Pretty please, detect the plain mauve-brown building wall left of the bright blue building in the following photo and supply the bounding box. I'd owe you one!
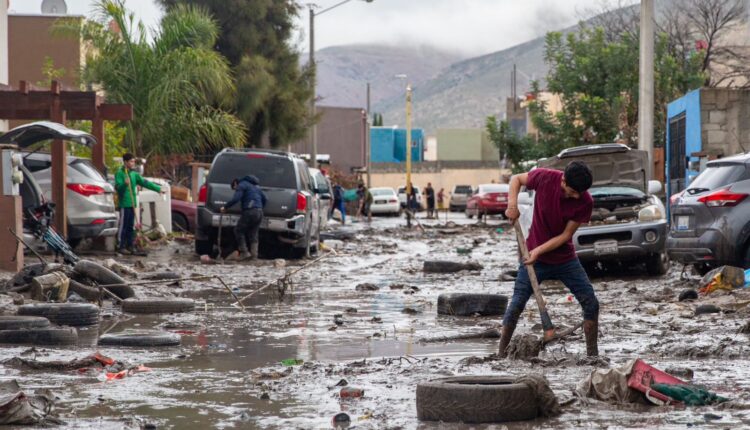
[290,106,367,173]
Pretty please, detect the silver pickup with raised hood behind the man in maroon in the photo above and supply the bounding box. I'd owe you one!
[519,144,669,275]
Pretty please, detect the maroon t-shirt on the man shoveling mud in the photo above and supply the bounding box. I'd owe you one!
[526,169,594,264]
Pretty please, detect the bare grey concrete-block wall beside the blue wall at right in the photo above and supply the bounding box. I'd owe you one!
[701,88,750,156]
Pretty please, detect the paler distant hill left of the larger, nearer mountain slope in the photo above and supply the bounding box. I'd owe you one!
[310,45,464,108]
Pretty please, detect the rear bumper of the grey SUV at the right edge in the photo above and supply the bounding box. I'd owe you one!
[667,230,737,265]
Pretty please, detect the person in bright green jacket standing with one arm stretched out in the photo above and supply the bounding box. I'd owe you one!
[115,153,162,255]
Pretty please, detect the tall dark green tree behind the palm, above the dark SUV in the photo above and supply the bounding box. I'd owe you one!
[159,0,317,146]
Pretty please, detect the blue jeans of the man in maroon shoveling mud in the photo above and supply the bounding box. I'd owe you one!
[503,258,599,326]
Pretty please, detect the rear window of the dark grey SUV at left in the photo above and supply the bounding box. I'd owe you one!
[208,153,297,189]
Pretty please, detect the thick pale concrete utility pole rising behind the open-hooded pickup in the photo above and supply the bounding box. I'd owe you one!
[638,0,654,177]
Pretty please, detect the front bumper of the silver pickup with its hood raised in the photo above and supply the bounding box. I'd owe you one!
[573,221,667,262]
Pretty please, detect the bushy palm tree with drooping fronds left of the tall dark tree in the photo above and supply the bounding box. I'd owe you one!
[57,0,245,155]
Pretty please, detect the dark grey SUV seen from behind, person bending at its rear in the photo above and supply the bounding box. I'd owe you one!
[195,149,320,257]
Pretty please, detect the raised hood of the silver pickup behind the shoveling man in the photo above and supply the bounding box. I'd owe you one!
[538,143,651,194]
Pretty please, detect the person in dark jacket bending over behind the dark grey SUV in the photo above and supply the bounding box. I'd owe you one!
[221,175,266,260]
